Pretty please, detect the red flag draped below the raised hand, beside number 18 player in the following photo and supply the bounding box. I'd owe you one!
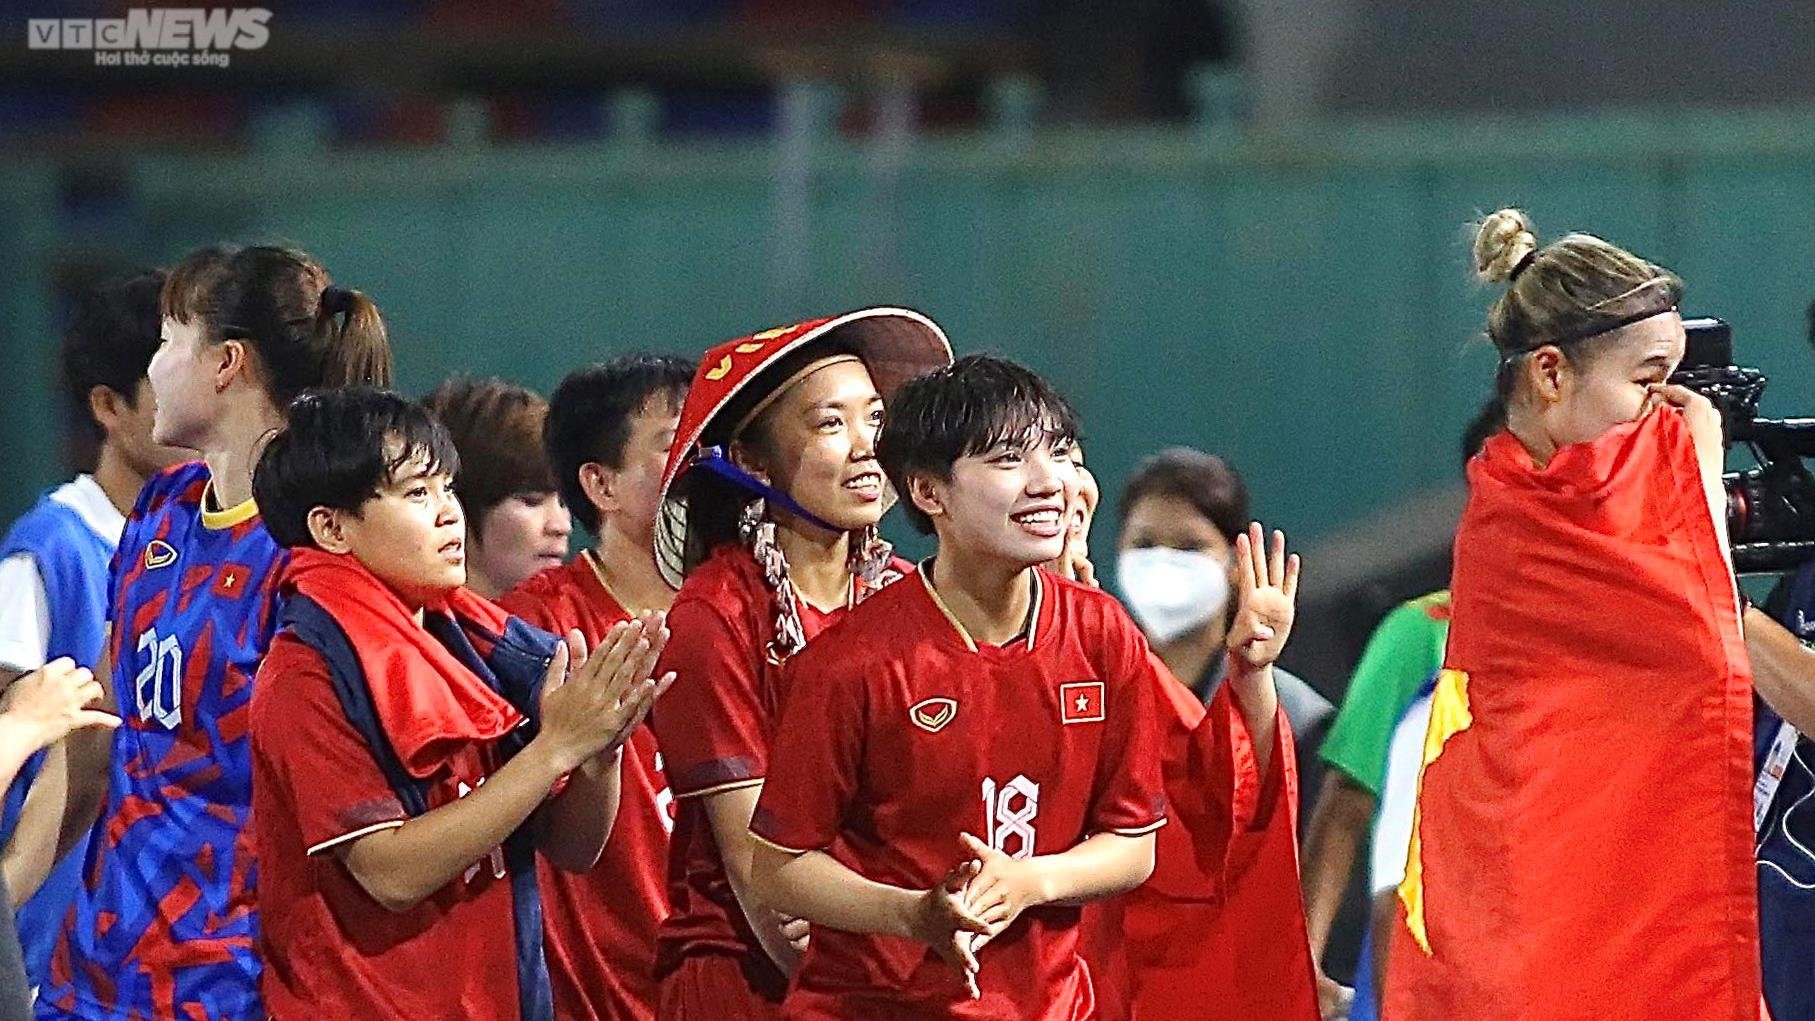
[1084,667,1318,1021]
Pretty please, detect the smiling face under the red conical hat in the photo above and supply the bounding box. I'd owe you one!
[735,359,886,531]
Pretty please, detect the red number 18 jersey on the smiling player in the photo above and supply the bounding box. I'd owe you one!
[751,569,1169,1021]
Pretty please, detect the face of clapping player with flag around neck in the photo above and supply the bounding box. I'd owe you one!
[323,453,466,606]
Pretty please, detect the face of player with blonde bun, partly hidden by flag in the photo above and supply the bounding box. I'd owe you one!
[1525,312,1686,448]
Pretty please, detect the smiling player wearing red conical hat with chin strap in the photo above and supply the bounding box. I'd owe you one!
[653,308,951,1021]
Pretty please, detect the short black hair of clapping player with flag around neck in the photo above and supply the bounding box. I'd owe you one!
[252,386,459,548]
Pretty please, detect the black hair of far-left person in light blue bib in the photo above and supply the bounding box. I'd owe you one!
[60,270,169,466]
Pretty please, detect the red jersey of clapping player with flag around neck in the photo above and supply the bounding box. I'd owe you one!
[250,631,519,1021]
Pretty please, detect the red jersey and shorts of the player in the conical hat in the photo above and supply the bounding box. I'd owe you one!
[650,546,913,999]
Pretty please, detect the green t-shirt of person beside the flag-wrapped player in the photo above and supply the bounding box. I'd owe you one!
[1321,589,1450,796]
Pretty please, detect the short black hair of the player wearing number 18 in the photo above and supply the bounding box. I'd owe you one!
[877,354,1078,535]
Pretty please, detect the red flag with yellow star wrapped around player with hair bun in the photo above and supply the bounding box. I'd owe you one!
[1385,410,1759,1021]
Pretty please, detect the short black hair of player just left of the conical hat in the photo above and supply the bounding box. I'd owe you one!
[543,354,695,535]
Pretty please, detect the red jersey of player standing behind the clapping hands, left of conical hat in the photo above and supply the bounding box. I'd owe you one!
[499,549,673,1021]
